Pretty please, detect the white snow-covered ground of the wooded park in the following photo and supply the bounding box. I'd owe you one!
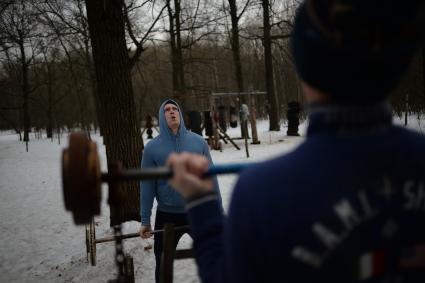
[0,114,425,282]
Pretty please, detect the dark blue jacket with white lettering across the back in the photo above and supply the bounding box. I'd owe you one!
[187,105,425,283]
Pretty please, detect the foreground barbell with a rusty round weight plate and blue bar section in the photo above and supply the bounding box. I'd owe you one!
[62,133,251,225]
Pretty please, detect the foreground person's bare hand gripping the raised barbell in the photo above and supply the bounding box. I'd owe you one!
[167,153,213,199]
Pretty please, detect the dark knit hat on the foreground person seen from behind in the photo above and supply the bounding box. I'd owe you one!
[292,0,425,104]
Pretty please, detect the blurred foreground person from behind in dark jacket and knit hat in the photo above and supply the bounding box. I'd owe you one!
[168,0,425,283]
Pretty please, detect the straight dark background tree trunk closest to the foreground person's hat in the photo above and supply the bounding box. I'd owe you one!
[262,0,280,131]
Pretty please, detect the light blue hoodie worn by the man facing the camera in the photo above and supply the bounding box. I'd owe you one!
[140,100,221,225]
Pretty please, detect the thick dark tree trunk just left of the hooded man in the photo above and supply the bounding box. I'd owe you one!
[86,0,142,226]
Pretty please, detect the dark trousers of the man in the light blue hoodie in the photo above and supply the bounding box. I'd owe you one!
[153,210,188,283]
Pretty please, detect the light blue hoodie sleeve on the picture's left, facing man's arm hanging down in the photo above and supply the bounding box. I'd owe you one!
[140,148,156,225]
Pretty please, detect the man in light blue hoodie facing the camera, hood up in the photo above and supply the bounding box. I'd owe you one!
[140,99,221,282]
